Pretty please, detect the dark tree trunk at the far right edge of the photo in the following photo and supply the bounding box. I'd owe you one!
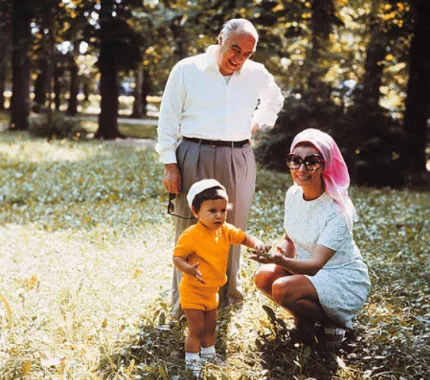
[404,0,430,172]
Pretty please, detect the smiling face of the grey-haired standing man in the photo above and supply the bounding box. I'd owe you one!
[218,32,255,75]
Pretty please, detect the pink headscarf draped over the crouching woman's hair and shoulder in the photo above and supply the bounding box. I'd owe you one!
[290,128,358,231]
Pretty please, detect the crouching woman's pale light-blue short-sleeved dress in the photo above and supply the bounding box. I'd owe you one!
[284,185,370,328]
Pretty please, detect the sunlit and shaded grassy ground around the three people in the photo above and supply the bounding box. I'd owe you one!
[0,132,430,379]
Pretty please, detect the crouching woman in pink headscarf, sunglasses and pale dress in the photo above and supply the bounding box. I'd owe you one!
[252,129,370,345]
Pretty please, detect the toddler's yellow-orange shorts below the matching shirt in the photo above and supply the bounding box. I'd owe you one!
[179,281,219,311]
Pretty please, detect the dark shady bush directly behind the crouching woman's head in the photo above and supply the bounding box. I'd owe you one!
[256,93,422,187]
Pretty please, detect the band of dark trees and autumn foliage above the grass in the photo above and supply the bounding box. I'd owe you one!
[0,0,430,186]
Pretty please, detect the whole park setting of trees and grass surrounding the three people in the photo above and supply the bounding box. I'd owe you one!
[0,0,430,379]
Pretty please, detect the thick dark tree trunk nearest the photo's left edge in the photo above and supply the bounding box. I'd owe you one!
[10,0,31,130]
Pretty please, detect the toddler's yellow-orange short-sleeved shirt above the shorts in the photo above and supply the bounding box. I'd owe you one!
[173,222,246,287]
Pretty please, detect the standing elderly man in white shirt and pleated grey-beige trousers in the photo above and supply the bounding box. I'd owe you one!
[156,19,284,312]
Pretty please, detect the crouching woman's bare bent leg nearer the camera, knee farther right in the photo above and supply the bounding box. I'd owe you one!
[272,274,331,323]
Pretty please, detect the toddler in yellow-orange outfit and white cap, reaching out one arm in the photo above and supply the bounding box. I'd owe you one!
[173,179,270,376]
